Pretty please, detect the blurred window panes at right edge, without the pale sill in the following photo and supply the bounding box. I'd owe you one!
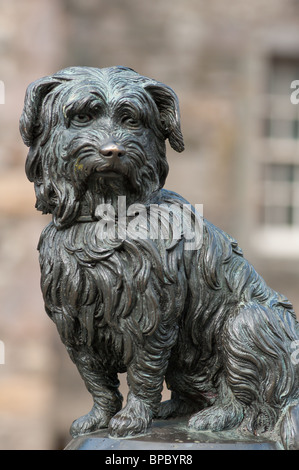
[261,57,299,227]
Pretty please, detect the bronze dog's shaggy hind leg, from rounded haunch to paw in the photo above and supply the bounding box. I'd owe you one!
[189,302,298,433]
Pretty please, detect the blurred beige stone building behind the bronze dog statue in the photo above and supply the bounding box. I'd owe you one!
[0,0,299,449]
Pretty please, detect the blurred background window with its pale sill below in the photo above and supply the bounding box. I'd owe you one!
[252,56,299,260]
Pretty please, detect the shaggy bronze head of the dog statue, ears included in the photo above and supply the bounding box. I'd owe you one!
[20,66,184,229]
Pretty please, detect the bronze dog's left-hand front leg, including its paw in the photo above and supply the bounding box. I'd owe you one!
[67,347,122,437]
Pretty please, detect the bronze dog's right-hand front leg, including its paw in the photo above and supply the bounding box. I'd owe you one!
[109,326,174,437]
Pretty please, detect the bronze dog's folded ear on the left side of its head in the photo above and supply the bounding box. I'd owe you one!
[19,77,61,147]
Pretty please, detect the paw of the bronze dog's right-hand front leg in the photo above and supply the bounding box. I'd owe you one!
[109,396,152,437]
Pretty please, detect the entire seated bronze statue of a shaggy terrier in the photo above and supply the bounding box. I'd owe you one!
[20,67,299,448]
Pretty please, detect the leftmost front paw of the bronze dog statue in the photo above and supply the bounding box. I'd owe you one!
[70,407,111,437]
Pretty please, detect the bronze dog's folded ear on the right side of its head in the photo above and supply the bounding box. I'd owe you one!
[144,82,184,152]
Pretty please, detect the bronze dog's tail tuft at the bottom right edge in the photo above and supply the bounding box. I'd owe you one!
[277,402,299,450]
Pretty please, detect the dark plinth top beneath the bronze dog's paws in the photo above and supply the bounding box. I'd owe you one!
[65,418,282,453]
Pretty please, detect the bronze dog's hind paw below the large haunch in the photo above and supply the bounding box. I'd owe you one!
[188,404,244,431]
